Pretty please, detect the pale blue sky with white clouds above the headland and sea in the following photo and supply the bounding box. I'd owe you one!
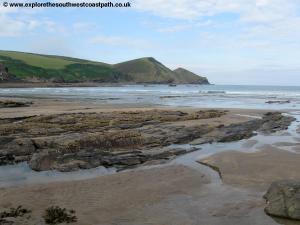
[0,0,300,86]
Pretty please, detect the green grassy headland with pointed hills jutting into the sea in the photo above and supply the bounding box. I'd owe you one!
[0,51,209,84]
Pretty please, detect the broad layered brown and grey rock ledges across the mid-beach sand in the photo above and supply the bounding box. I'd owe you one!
[0,110,294,171]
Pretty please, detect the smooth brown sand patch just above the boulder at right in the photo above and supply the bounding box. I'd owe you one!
[200,145,300,191]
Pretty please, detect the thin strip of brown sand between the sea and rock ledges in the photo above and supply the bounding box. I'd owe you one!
[0,96,278,118]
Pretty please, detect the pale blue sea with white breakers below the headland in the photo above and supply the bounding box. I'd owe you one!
[0,85,300,110]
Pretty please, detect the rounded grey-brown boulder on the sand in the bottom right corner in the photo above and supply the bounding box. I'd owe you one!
[264,180,300,220]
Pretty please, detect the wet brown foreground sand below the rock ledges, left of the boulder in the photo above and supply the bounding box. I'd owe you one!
[0,166,277,225]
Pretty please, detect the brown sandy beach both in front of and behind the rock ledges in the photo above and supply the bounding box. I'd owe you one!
[0,95,300,225]
